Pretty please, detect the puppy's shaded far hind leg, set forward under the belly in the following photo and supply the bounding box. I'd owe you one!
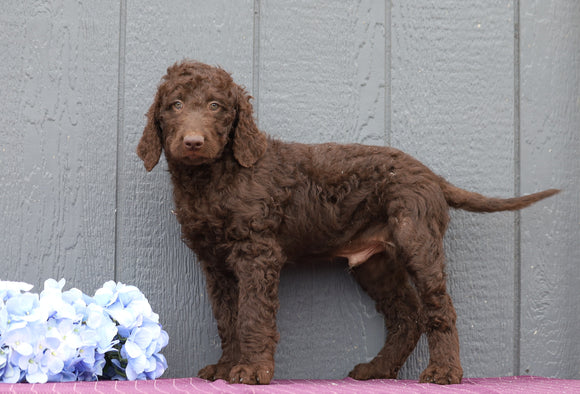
[348,253,422,380]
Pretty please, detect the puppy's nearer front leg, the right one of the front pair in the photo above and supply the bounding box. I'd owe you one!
[229,240,284,384]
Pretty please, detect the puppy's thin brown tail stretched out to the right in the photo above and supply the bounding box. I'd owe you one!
[439,178,560,212]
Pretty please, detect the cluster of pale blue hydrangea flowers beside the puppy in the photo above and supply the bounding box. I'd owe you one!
[0,279,168,383]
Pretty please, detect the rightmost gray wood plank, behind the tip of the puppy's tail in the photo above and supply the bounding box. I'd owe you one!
[520,0,580,379]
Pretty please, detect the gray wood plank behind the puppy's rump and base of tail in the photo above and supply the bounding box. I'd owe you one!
[391,0,514,378]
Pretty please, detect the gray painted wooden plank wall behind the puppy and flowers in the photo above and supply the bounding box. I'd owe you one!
[0,0,580,379]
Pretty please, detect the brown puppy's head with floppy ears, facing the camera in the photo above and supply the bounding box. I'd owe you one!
[137,61,267,171]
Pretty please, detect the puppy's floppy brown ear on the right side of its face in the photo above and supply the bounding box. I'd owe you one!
[233,86,268,167]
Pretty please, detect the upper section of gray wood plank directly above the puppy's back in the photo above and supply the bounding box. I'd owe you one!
[259,0,385,145]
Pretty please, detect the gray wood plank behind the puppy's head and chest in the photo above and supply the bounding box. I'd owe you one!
[117,0,254,377]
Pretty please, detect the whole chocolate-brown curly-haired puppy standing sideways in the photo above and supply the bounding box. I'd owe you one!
[137,61,557,384]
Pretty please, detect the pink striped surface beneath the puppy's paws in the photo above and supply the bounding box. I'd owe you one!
[0,376,580,394]
